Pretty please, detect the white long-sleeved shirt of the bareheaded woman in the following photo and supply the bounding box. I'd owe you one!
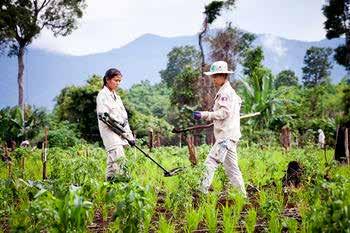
[96,86,133,151]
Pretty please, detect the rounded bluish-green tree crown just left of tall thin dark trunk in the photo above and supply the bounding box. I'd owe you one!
[160,45,200,87]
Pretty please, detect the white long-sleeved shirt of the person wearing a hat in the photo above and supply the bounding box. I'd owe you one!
[201,81,242,142]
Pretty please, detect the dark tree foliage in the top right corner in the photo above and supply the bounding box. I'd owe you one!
[322,0,350,71]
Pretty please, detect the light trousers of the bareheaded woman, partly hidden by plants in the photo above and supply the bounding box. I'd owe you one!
[106,145,125,178]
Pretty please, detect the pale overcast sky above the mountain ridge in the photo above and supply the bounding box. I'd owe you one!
[32,0,325,55]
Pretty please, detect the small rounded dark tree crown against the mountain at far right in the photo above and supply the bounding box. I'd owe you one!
[302,47,332,87]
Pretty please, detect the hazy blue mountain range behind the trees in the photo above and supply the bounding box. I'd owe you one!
[0,34,345,108]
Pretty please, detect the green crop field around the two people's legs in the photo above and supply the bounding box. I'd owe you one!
[0,144,350,232]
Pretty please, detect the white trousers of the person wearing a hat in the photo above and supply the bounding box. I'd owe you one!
[201,140,247,196]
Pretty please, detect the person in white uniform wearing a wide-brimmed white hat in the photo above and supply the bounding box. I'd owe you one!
[193,61,246,196]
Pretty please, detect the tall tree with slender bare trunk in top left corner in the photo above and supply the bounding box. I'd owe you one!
[0,0,85,118]
